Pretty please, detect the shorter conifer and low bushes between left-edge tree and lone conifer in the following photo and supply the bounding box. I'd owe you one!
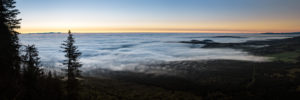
[16,45,65,100]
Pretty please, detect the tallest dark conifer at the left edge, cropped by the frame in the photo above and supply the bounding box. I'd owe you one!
[0,0,21,100]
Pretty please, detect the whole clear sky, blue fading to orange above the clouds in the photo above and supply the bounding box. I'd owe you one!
[16,0,300,33]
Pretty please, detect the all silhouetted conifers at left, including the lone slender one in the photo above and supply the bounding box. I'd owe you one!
[0,0,81,100]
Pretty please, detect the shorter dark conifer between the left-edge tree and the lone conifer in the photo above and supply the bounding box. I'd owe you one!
[22,45,43,100]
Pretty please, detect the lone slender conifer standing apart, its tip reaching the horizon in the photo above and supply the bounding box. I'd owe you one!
[62,30,82,100]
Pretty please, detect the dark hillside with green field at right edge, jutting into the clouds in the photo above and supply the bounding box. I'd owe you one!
[204,36,300,63]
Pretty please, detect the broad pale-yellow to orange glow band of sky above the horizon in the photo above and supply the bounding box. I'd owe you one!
[18,21,300,33]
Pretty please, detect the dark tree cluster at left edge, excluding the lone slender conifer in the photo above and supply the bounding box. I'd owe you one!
[0,0,64,100]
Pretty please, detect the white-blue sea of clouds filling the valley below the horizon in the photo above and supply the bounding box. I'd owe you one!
[20,33,288,71]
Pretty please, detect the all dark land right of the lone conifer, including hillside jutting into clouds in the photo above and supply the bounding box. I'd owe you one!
[82,37,300,100]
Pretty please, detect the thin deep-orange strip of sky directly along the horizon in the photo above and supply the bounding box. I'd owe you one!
[17,28,300,34]
